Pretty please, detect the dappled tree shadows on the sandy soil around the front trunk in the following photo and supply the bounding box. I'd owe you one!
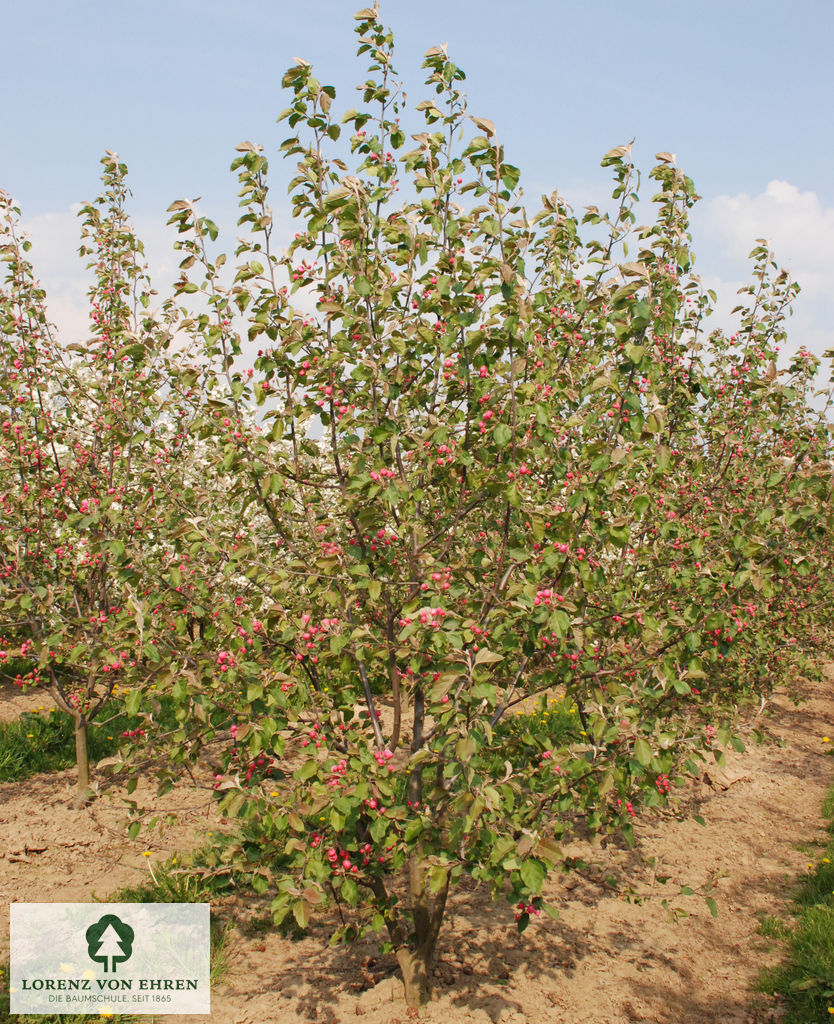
[211,675,834,1024]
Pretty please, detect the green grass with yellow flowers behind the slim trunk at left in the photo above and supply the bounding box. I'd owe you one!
[0,698,138,782]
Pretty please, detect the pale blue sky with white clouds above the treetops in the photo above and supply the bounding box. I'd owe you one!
[0,0,834,362]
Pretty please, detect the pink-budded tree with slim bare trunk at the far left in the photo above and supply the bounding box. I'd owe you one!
[0,154,182,803]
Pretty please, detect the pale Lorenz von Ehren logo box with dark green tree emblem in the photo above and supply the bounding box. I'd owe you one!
[9,903,211,1014]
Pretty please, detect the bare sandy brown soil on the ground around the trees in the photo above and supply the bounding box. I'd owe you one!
[0,672,834,1024]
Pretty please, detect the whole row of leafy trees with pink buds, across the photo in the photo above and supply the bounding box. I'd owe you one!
[0,9,834,1005]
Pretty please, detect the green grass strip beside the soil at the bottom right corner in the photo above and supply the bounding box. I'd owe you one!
[756,786,834,1024]
